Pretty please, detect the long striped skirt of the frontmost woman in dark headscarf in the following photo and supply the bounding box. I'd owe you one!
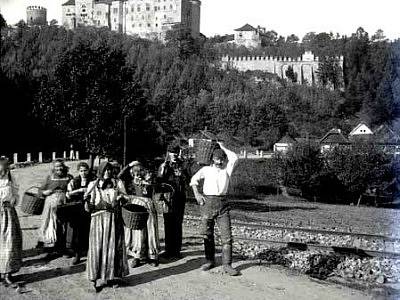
[87,211,129,282]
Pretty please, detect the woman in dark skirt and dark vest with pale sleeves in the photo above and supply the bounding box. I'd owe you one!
[66,162,94,265]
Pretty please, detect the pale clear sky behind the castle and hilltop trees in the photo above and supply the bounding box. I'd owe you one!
[0,0,400,39]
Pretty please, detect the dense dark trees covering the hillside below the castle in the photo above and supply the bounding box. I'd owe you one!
[0,22,400,164]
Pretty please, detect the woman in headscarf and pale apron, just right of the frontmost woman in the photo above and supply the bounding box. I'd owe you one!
[119,161,160,268]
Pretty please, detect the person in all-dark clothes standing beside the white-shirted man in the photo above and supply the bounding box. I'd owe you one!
[158,146,190,258]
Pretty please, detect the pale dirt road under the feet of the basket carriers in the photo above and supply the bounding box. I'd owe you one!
[0,165,373,300]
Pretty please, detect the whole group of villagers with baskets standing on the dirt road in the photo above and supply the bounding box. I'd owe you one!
[0,143,238,292]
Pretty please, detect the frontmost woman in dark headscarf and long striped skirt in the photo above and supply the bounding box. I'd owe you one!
[85,162,129,292]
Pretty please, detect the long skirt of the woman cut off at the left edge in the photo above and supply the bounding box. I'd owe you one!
[0,207,22,274]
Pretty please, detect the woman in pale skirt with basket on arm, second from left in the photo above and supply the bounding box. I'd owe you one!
[37,159,73,254]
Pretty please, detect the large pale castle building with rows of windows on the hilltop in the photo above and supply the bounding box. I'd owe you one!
[62,0,201,40]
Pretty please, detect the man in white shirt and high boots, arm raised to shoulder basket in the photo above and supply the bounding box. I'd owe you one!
[190,143,239,276]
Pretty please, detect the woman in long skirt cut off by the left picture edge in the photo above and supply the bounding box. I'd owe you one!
[0,157,22,284]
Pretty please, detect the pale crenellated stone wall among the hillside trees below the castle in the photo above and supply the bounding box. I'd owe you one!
[222,51,343,85]
